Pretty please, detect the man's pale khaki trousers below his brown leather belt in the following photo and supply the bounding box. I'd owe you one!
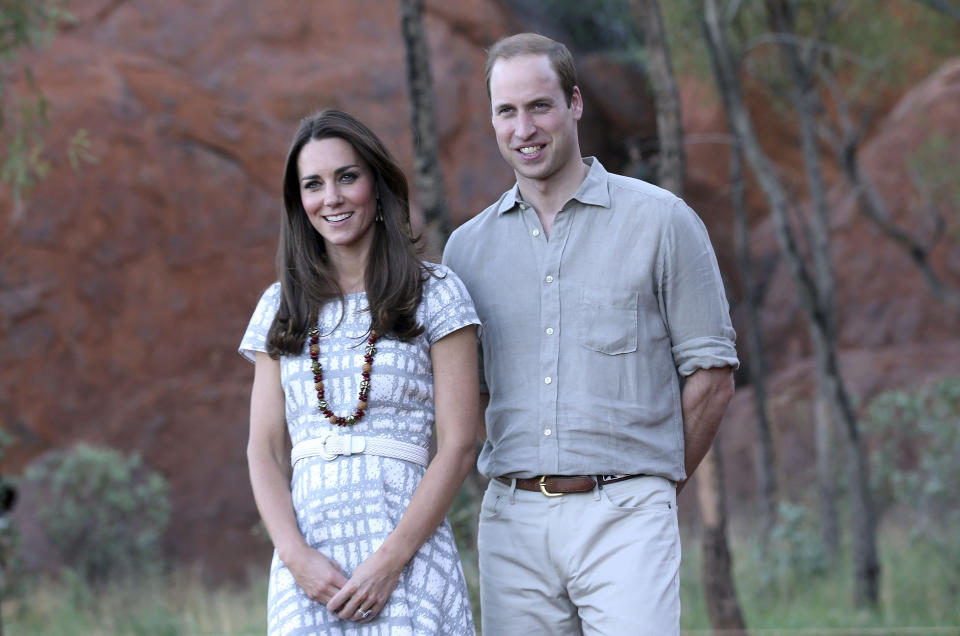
[478,477,680,636]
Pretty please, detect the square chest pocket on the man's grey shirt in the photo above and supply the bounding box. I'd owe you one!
[580,287,637,355]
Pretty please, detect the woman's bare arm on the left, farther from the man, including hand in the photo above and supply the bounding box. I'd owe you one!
[247,352,347,603]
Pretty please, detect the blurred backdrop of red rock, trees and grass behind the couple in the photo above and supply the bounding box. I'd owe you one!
[0,0,960,634]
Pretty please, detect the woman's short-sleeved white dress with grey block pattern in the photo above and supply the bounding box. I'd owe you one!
[240,265,480,636]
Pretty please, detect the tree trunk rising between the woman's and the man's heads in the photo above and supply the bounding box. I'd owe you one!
[400,0,450,261]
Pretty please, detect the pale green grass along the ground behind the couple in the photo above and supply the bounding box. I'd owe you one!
[3,528,960,636]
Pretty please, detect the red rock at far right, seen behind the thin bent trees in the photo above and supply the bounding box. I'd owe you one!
[700,58,960,503]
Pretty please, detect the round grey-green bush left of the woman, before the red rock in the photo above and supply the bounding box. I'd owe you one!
[25,444,170,583]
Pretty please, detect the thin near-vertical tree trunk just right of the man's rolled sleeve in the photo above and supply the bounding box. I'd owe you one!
[730,143,777,550]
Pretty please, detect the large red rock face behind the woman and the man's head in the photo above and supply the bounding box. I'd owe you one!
[0,0,654,574]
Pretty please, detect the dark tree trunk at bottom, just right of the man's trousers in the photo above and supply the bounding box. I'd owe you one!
[697,441,747,634]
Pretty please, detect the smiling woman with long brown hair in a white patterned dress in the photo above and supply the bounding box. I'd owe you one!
[240,110,479,634]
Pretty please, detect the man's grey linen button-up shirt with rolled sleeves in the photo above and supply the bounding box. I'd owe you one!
[443,157,738,481]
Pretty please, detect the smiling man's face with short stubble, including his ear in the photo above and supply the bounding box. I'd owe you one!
[490,55,583,181]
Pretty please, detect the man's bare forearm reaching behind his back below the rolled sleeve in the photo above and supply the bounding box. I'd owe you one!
[677,367,733,492]
